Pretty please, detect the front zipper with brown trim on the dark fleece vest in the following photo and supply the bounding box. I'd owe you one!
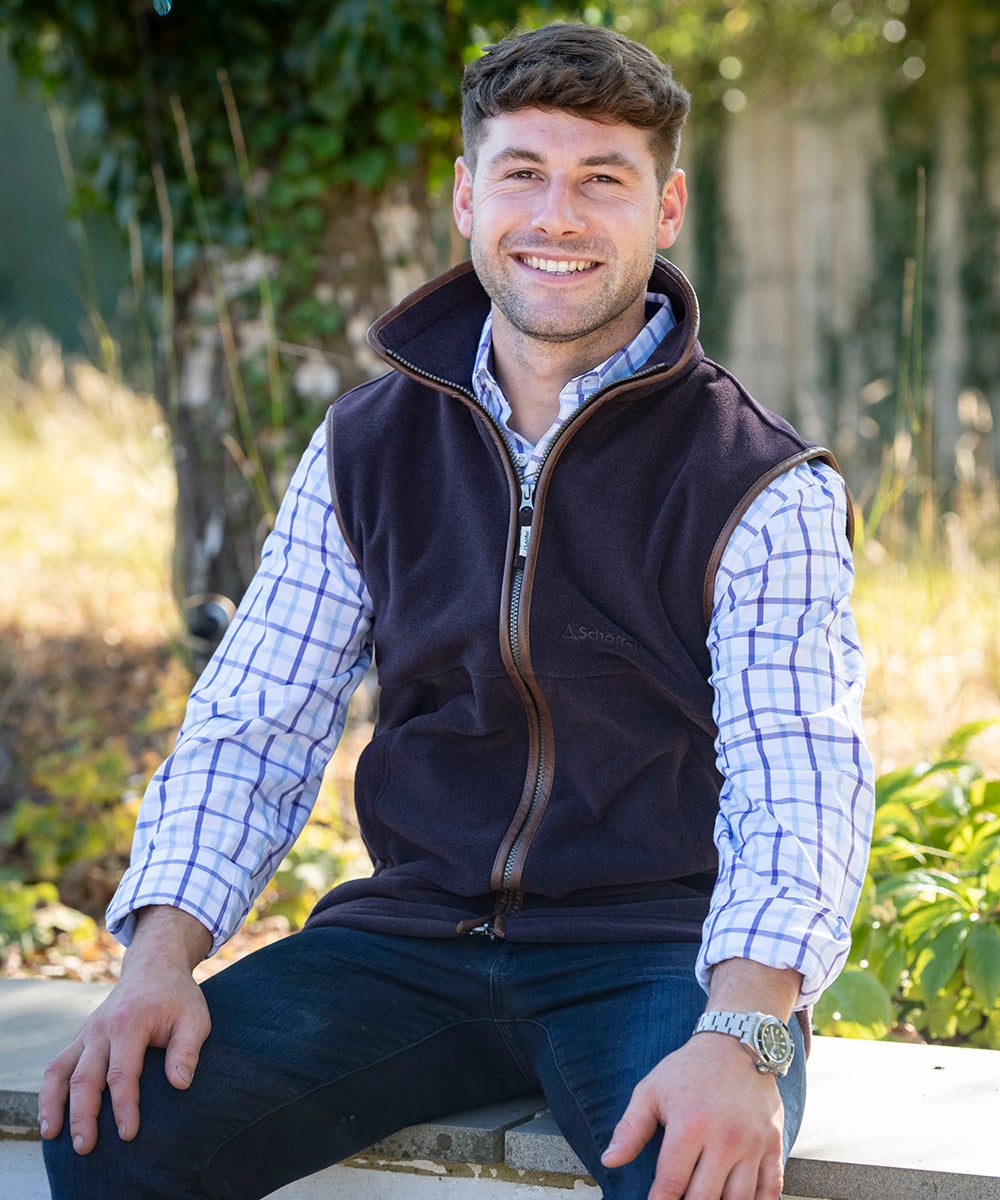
[382,346,661,940]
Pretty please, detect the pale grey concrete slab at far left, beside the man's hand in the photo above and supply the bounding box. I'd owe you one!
[0,979,112,1128]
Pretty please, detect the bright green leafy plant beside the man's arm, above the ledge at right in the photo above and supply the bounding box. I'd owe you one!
[815,721,1000,1049]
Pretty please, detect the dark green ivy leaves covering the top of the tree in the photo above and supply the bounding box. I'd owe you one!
[5,0,550,309]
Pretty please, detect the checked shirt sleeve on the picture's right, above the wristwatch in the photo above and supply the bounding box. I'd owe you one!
[697,463,874,1007]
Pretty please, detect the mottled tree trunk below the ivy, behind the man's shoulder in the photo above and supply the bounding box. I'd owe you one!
[161,180,447,658]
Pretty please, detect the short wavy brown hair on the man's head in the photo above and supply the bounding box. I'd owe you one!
[462,24,691,186]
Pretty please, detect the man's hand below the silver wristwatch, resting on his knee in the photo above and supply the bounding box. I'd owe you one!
[601,1033,784,1200]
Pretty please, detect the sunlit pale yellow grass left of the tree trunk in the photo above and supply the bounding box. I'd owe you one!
[0,335,179,647]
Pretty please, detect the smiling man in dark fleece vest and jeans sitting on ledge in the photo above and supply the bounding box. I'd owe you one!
[40,26,872,1200]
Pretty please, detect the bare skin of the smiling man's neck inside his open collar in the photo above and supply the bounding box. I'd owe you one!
[493,294,646,445]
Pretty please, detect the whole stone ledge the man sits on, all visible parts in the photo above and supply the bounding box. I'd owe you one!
[0,979,1000,1200]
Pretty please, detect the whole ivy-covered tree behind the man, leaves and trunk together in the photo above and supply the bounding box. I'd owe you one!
[0,0,573,601]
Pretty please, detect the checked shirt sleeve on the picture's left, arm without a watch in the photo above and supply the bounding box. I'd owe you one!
[107,428,372,952]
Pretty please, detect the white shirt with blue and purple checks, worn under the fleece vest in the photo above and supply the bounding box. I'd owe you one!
[107,296,874,1004]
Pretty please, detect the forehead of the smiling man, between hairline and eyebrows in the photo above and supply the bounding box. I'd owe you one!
[477,108,655,173]
